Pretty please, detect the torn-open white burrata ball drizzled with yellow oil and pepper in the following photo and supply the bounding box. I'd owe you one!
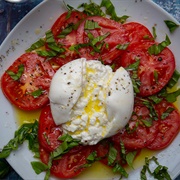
[49,58,134,145]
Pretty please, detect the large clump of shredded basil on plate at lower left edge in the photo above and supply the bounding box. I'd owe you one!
[0,121,39,159]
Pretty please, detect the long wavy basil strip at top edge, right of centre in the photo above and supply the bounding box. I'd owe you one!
[100,0,129,23]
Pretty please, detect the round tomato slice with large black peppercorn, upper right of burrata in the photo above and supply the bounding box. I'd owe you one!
[121,42,175,96]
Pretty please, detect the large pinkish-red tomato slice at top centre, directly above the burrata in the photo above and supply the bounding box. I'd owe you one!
[77,16,128,63]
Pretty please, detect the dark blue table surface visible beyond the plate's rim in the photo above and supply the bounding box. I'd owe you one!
[0,0,180,180]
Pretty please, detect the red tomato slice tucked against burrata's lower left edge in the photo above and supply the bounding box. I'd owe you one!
[38,105,62,152]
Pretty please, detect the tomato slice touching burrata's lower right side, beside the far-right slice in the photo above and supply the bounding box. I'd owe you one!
[112,98,158,149]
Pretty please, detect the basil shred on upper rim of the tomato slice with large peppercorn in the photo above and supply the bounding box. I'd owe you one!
[148,35,171,55]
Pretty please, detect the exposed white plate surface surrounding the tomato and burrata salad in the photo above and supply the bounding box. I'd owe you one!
[0,0,180,179]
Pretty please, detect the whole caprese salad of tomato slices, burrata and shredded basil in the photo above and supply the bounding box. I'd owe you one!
[0,0,180,179]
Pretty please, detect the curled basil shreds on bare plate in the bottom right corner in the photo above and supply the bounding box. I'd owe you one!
[141,156,171,180]
